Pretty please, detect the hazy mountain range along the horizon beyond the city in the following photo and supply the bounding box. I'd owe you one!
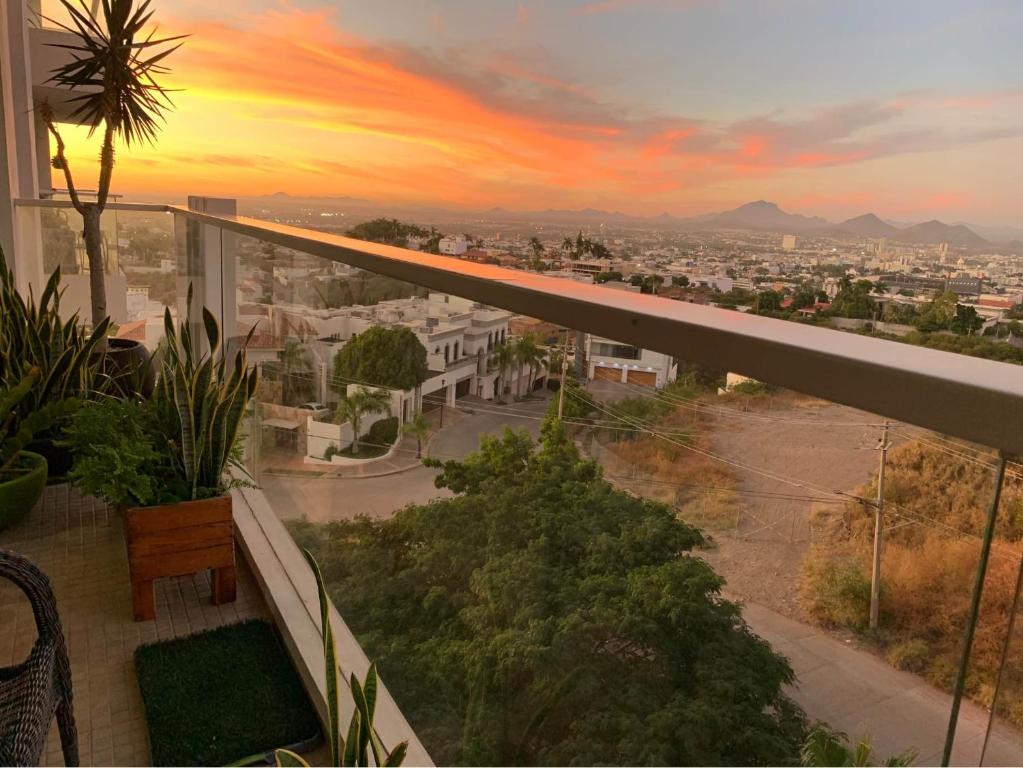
[250,192,1023,247]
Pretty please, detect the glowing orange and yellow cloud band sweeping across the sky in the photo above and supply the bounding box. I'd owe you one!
[53,0,1020,218]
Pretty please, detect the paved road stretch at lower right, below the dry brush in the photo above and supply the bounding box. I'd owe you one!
[743,603,1023,765]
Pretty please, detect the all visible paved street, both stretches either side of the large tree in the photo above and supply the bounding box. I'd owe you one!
[263,402,1023,765]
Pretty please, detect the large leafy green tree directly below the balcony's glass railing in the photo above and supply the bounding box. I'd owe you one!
[294,420,805,765]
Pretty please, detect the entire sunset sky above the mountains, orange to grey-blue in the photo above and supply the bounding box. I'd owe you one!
[53,0,1023,225]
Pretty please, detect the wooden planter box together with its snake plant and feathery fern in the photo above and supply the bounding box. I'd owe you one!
[68,290,258,621]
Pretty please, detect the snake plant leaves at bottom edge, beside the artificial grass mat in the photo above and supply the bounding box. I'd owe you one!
[274,550,408,768]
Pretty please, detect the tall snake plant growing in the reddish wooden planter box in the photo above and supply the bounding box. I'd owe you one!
[155,287,259,499]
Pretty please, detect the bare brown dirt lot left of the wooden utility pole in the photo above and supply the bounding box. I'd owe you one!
[601,393,908,620]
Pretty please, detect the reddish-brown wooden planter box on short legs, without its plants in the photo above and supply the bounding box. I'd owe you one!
[125,496,235,622]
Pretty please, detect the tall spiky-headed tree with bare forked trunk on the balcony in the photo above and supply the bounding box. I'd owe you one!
[37,0,185,324]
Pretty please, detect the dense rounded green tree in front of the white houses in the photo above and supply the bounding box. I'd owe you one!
[333,325,429,395]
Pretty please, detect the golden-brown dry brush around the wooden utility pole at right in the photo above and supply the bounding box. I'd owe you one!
[801,443,1023,725]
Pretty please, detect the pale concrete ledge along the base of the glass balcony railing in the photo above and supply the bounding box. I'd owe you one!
[231,488,434,766]
